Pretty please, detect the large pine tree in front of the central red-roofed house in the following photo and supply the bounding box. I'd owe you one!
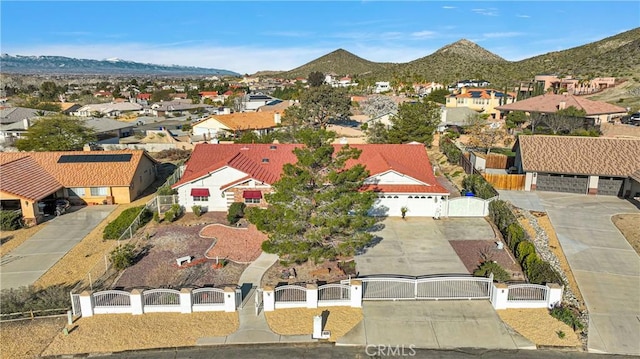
[246,129,377,262]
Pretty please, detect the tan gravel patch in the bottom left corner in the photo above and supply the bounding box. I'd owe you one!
[0,316,67,359]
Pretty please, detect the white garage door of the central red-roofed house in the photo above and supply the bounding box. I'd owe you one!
[371,194,438,217]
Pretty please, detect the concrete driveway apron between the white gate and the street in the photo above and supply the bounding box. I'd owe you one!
[337,300,535,349]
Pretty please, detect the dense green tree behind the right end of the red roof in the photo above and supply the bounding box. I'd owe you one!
[388,100,440,146]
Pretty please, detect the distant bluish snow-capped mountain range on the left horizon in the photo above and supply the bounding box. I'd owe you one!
[0,54,240,76]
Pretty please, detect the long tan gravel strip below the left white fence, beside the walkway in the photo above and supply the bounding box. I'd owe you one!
[42,312,239,355]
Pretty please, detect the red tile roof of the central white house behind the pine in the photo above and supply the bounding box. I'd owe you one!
[173,144,448,193]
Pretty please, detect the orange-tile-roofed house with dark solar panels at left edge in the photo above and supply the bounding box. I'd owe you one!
[0,150,157,224]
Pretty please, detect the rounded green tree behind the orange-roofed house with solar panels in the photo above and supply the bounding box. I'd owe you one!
[16,115,97,151]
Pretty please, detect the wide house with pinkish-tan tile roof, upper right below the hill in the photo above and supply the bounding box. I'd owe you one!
[496,93,627,126]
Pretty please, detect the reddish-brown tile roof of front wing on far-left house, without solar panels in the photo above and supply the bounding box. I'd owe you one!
[0,157,62,201]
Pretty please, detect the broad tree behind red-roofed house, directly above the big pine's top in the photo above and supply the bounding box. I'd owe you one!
[298,85,351,129]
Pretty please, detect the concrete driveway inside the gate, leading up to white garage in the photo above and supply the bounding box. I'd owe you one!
[355,217,495,276]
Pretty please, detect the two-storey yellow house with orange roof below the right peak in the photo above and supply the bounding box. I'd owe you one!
[445,87,516,119]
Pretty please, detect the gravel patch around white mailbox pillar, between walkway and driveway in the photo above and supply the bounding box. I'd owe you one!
[265,307,363,342]
